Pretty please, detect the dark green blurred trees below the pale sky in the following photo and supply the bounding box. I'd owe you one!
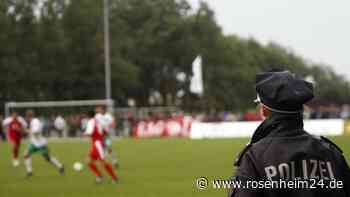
[0,0,350,111]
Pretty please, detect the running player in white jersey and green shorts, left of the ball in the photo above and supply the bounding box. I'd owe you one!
[24,110,64,177]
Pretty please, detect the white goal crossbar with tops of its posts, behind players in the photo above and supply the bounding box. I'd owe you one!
[5,99,114,117]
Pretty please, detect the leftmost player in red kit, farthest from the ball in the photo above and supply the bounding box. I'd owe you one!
[3,111,27,167]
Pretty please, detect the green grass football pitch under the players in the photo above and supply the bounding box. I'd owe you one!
[0,137,350,197]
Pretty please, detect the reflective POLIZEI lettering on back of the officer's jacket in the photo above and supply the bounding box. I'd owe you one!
[265,159,334,180]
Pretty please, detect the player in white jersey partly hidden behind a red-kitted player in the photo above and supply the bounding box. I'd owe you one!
[95,106,119,167]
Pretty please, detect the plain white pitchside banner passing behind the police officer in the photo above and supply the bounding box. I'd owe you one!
[190,119,344,139]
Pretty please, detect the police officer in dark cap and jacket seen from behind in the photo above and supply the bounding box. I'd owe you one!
[229,71,350,197]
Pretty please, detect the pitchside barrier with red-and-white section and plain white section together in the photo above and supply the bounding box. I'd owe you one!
[133,116,345,139]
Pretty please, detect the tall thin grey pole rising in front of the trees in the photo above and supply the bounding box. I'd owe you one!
[103,0,112,100]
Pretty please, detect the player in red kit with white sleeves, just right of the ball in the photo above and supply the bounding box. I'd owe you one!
[84,111,118,183]
